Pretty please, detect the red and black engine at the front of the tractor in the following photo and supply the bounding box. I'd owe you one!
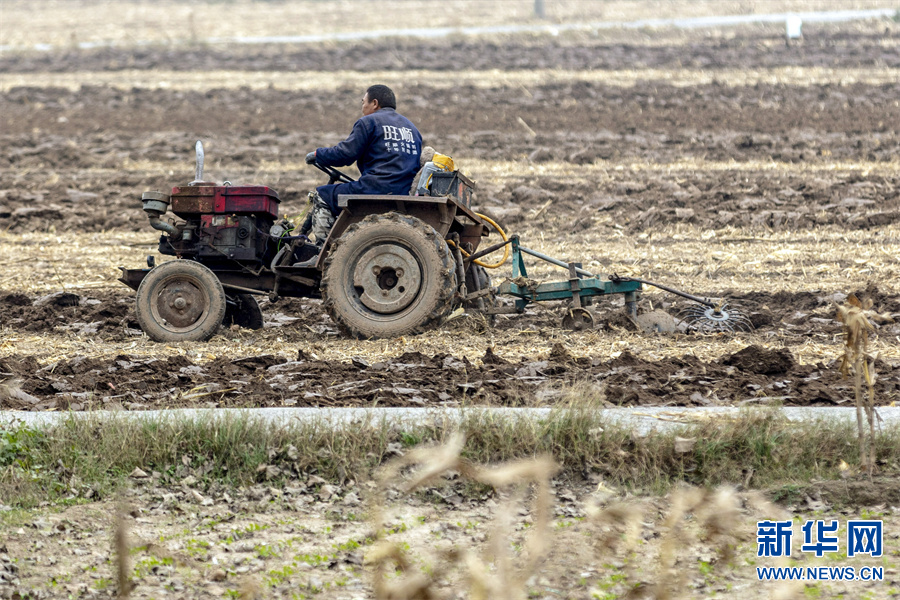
[142,182,279,264]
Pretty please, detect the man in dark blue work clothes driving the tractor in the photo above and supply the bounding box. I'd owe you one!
[295,85,422,266]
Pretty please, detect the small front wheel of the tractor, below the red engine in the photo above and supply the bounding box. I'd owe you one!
[135,260,225,342]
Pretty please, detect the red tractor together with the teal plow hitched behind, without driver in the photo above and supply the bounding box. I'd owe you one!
[119,141,752,342]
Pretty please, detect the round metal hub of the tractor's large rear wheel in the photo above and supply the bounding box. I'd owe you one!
[353,245,422,314]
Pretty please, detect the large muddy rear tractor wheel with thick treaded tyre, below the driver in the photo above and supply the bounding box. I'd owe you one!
[321,213,457,338]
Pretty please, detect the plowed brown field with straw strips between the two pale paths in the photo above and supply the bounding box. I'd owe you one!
[0,20,900,410]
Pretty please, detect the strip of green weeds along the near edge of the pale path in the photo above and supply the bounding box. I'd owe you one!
[0,406,900,508]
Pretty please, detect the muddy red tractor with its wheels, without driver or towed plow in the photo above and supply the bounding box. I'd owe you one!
[119,141,490,342]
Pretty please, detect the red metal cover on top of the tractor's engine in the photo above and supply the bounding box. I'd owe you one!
[171,184,280,219]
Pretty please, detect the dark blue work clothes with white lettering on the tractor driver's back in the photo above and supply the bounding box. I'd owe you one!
[316,108,422,215]
